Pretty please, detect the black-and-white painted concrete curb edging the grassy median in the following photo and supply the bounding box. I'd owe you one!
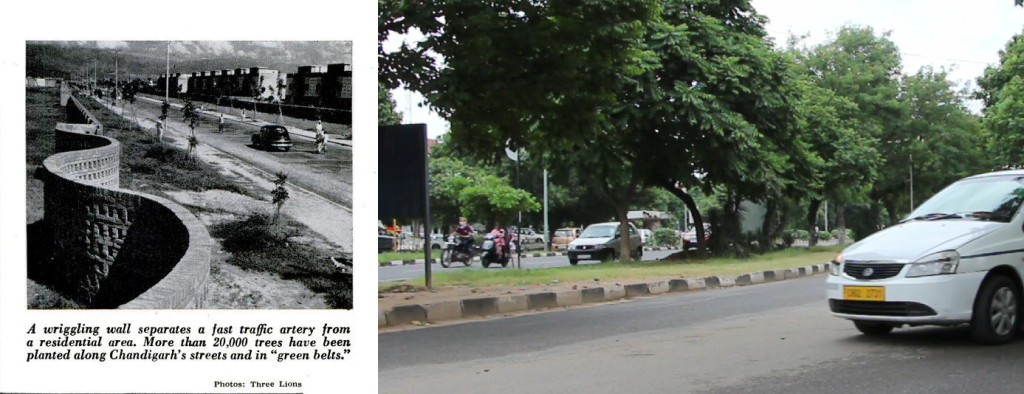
[377,263,828,327]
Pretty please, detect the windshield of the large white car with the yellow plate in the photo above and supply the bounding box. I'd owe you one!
[904,175,1024,222]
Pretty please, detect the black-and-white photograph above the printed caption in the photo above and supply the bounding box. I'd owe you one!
[25,40,353,309]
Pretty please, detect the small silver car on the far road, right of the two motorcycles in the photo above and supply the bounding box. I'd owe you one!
[568,222,643,265]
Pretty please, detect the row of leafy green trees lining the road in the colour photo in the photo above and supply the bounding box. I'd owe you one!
[378,0,1024,260]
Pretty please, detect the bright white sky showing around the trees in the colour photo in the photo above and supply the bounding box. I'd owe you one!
[392,0,1024,138]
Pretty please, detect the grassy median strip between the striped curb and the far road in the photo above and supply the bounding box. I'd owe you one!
[378,246,845,291]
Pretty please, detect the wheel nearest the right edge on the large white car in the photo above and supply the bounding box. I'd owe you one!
[971,275,1021,345]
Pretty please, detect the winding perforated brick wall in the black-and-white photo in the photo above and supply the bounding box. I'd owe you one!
[43,97,212,309]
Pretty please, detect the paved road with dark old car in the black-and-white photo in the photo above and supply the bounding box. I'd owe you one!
[135,94,352,209]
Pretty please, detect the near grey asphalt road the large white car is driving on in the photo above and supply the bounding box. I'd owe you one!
[378,275,1024,393]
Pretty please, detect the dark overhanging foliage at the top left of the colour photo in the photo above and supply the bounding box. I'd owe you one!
[377,0,659,157]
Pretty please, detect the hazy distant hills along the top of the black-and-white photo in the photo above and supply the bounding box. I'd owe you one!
[26,41,352,79]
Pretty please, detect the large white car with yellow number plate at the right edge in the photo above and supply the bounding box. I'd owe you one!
[826,170,1024,344]
